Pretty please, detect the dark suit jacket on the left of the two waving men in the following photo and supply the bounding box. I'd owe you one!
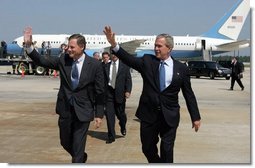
[29,50,104,121]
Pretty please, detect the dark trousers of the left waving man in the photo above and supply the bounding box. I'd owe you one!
[58,107,90,163]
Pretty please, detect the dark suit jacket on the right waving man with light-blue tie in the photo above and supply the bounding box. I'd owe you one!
[114,47,200,127]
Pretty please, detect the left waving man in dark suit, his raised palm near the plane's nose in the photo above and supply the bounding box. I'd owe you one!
[24,28,104,163]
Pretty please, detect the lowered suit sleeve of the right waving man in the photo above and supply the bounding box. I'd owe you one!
[182,67,201,122]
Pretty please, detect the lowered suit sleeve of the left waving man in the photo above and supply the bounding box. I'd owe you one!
[95,63,105,118]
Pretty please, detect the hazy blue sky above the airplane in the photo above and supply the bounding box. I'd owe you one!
[0,0,252,55]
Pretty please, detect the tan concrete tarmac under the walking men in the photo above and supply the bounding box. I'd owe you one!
[0,66,252,165]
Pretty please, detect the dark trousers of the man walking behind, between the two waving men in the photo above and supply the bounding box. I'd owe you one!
[105,86,127,139]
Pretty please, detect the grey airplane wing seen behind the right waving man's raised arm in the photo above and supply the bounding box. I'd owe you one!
[104,39,146,55]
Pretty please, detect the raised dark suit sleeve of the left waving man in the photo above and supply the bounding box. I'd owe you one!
[28,49,59,70]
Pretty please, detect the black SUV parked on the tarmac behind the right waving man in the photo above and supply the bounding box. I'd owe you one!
[188,61,231,80]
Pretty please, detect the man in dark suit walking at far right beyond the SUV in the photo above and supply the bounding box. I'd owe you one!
[230,57,244,91]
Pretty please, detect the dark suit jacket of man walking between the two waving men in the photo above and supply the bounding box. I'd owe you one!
[104,60,132,103]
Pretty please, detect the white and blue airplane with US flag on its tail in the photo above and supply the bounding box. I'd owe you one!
[4,0,250,59]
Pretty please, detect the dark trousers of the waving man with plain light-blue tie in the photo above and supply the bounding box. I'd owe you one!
[140,113,177,163]
